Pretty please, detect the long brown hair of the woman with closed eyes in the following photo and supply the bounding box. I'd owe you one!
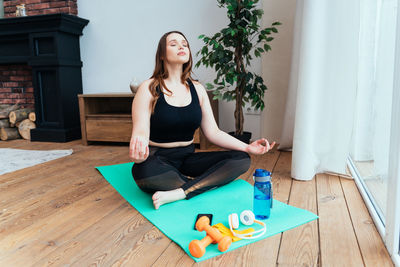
[149,31,193,113]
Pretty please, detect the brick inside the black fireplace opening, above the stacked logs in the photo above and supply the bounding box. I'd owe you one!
[0,65,34,108]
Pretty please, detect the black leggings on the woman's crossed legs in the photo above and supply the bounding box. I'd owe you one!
[132,144,250,199]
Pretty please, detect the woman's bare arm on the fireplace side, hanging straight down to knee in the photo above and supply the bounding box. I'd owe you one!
[129,80,153,163]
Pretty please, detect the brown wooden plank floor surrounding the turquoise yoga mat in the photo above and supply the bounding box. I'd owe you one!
[0,140,392,267]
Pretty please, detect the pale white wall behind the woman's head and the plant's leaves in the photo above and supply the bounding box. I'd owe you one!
[78,0,287,139]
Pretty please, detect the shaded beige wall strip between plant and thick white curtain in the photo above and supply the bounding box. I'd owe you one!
[261,0,296,142]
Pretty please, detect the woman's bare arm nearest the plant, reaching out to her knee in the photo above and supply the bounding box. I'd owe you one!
[195,83,275,154]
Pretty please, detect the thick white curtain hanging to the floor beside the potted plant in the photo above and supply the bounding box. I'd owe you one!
[279,0,360,180]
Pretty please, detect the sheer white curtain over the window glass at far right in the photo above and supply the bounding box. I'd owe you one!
[350,0,397,179]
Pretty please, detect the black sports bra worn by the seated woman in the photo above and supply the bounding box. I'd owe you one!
[150,79,201,143]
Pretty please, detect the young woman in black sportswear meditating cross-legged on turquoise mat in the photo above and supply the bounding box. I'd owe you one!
[129,31,275,209]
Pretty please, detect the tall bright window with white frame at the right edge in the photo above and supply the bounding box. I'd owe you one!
[348,0,400,265]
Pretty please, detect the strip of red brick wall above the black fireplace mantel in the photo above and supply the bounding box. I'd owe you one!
[3,0,78,18]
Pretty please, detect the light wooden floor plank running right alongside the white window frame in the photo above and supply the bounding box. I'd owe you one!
[340,178,393,267]
